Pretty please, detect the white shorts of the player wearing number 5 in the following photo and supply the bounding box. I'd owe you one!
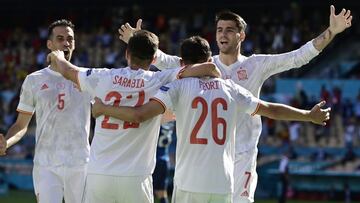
[33,165,87,203]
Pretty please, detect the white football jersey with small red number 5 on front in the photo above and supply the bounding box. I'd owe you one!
[17,67,91,166]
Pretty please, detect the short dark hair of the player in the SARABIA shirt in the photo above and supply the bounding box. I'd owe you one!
[127,30,159,64]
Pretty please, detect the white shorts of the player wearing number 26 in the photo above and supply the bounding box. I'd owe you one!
[171,186,232,203]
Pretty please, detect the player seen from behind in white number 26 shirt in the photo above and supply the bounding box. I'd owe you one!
[93,37,330,203]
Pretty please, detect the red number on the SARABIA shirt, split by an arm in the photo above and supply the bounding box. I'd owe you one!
[101,91,145,130]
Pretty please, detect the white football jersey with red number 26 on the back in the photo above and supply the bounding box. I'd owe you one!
[153,78,259,194]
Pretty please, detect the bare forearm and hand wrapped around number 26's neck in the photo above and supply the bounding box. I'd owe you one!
[179,62,221,78]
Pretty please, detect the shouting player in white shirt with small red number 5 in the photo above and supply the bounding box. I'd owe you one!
[0,20,91,203]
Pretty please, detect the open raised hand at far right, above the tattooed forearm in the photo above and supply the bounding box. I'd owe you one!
[329,5,352,35]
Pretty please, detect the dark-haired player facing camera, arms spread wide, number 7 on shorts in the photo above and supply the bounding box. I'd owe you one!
[119,5,352,203]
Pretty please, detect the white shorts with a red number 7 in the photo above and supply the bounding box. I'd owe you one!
[233,148,258,203]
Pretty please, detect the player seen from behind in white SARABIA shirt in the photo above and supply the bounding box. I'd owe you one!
[48,30,220,203]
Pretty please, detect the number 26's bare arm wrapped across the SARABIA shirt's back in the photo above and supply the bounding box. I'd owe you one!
[92,98,165,123]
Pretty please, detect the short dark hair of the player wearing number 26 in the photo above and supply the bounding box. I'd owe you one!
[180,36,211,64]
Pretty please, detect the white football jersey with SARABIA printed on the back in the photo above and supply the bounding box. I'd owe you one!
[78,67,181,176]
